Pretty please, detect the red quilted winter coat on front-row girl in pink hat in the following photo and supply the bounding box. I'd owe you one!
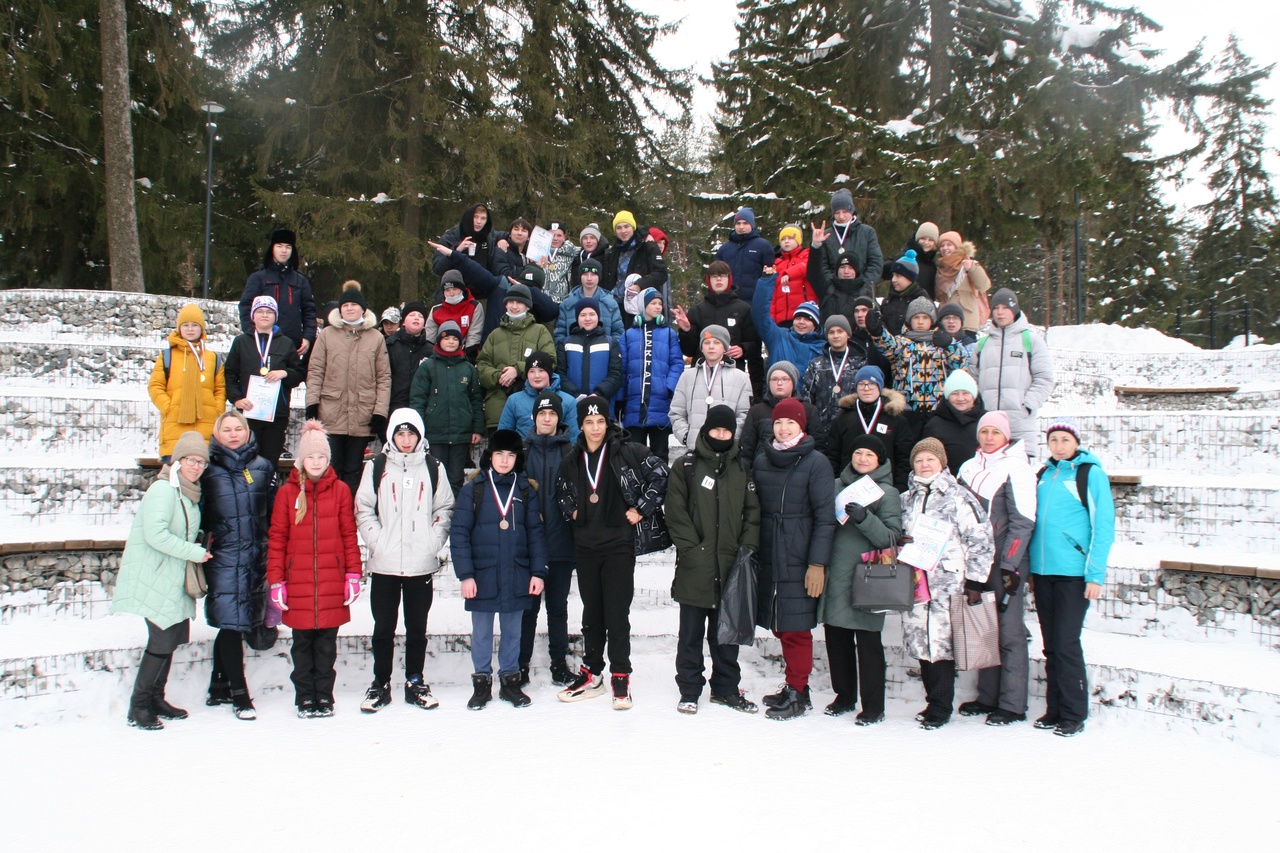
[266,467,361,630]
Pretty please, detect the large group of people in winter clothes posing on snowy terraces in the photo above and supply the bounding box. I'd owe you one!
[115,191,1114,735]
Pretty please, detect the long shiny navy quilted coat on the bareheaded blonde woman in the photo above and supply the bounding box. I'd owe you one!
[200,437,275,631]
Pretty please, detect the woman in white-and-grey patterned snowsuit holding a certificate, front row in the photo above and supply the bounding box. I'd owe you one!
[899,438,996,729]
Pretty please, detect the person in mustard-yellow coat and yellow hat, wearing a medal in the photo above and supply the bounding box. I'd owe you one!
[147,304,227,457]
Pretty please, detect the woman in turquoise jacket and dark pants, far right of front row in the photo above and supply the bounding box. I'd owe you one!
[1032,418,1116,738]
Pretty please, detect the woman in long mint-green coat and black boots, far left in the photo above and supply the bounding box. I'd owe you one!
[111,432,212,729]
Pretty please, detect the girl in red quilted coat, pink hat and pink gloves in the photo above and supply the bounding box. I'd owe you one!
[266,420,361,717]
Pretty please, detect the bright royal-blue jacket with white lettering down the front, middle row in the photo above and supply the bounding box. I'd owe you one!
[622,321,685,429]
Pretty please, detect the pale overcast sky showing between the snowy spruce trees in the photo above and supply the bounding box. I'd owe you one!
[643,0,1280,212]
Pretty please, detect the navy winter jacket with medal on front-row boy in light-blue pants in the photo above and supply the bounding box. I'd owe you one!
[449,469,547,613]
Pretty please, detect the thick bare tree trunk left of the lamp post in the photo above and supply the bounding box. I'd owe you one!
[99,0,146,293]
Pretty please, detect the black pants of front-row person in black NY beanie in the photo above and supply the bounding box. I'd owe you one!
[577,548,636,675]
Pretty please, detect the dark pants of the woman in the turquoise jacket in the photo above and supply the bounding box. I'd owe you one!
[1036,575,1089,722]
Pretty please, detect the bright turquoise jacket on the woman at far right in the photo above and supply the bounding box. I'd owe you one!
[1032,450,1116,584]
